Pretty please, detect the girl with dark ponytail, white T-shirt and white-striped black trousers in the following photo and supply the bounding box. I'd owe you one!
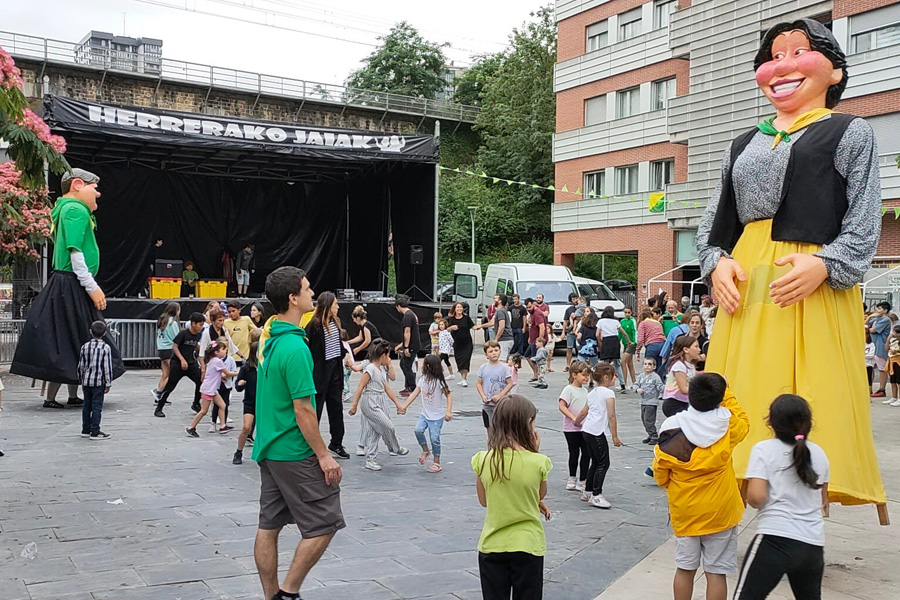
[734,394,828,600]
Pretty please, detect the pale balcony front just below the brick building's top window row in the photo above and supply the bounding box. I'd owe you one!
[553,27,672,93]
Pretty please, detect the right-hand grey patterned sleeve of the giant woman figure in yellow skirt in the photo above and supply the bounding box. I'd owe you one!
[816,119,881,289]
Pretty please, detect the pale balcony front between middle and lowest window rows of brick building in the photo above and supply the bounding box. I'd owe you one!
[553,110,669,162]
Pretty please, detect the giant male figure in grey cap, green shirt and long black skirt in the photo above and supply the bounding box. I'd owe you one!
[10,169,125,408]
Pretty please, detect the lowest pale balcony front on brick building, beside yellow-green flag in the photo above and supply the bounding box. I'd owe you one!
[550,192,666,233]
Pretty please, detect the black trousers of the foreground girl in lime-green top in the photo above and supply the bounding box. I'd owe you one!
[478,552,544,600]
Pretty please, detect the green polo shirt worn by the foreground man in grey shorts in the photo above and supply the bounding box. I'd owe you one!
[253,318,316,462]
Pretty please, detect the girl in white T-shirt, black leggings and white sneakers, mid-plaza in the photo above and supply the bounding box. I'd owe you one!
[575,363,622,508]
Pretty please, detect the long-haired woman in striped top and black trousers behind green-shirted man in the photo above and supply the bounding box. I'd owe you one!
[306,292,350,458]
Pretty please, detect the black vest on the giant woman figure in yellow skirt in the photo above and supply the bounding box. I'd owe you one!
[709,113,856,252]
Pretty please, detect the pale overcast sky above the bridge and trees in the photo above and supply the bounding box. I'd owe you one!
[0,0,549,84]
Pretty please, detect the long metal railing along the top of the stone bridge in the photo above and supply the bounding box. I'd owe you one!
[0,31,479,123]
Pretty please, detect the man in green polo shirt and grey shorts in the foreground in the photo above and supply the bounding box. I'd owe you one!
[253,267,345,600]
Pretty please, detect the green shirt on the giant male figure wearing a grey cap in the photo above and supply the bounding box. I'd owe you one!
[50,196,100,275]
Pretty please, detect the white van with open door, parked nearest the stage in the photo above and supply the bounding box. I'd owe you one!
[454,262,580,336]
